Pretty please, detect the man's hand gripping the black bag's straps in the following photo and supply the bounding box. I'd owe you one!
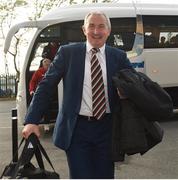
[22,124,40,139]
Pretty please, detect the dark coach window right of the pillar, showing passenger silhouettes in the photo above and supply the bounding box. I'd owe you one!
[143,16,178,48]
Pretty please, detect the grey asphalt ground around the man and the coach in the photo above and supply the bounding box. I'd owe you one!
[0,101,178,179]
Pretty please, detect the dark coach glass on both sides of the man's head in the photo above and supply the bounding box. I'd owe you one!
[29,18,136,71]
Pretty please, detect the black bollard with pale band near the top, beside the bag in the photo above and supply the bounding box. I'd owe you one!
[12,108,18,162]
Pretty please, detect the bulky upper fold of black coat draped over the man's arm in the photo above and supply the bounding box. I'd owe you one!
[113,69,173,121]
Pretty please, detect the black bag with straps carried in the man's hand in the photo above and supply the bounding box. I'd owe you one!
[1,134,60,179]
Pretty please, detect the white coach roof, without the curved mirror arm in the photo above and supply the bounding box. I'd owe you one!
[41,2,178,22]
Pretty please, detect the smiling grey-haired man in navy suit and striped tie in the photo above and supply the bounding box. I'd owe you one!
[22,11,132,179]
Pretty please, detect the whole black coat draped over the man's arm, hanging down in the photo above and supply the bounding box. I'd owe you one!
[112,69,173,161]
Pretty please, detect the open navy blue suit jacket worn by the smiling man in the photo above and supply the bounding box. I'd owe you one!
[25,43,132,149]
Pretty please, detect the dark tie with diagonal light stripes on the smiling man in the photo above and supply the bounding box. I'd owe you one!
[91,48,106,120]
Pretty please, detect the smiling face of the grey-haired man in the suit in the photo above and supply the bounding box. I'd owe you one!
[83,14,111,48]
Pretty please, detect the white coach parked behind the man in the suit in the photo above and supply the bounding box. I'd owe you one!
[4,2,178,122]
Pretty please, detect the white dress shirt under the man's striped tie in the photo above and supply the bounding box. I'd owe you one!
[79,41,110,116]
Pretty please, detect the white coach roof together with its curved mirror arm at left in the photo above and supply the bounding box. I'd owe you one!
[4,0,178,53]
